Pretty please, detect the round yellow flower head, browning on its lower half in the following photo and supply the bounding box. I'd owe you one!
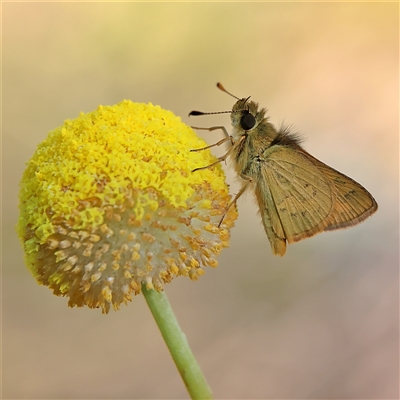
[17,100,237,313]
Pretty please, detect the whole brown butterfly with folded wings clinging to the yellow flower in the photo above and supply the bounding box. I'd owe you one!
[189,83,378,256]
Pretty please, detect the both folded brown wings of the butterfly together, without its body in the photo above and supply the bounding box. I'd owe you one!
[256,145,377,255]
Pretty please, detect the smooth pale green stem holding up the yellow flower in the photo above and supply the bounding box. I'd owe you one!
[142,285,212,399]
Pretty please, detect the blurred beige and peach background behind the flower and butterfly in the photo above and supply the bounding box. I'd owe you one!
[2,2,399,399]
